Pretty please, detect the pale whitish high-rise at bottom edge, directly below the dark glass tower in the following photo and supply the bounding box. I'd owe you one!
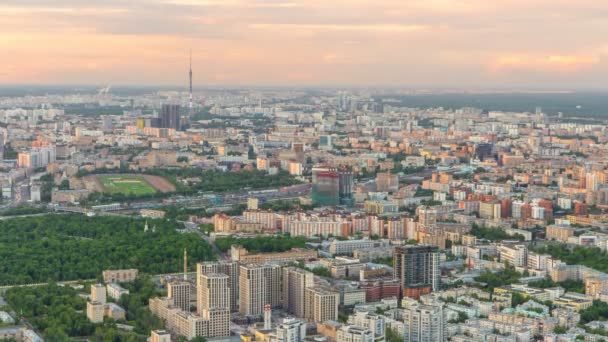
[403,305,446,342]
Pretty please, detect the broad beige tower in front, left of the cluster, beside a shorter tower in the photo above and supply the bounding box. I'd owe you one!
[196,273,230,315]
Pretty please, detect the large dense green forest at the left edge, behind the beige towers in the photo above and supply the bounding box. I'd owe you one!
[0,214,215,285]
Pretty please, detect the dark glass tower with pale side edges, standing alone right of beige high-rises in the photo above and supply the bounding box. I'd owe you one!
[393,245,441,299]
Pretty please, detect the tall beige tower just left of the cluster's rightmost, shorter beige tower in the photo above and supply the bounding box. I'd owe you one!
[283,267,314,317]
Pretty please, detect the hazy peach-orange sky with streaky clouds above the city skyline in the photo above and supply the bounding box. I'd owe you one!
[0,0,608,90]
